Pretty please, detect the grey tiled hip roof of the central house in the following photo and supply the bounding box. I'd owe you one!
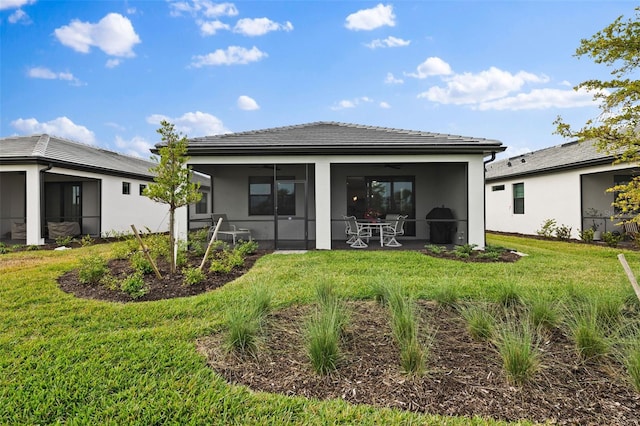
[172,121,506,156]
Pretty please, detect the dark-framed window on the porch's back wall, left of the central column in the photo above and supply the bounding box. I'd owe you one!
[249,176,296,216]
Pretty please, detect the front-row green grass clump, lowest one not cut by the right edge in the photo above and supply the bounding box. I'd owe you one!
[495,321,540,385]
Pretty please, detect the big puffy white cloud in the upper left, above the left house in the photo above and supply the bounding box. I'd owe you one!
[54,13,140,57]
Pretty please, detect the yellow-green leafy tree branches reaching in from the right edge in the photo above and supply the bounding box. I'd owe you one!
[554,7,640,221]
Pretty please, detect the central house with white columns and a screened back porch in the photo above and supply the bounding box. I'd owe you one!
[168,122,505,249]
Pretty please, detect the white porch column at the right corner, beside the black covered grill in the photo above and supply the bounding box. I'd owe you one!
[467,159,486,248]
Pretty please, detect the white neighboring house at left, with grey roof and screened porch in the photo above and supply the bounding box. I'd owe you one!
[0,135,178,244]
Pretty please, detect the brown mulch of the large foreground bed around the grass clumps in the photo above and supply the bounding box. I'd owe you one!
[198,301,640,425]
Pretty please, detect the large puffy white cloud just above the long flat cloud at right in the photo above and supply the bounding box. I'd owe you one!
[418,67,549,105]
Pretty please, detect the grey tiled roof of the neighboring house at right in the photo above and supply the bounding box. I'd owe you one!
[485,141,614,181]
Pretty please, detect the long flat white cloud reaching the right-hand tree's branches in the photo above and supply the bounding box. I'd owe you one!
[476,85,606,111]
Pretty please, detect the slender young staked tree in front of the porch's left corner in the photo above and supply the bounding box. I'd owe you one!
[144,120,202,274]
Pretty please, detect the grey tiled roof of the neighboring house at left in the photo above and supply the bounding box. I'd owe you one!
[0,134,155,179]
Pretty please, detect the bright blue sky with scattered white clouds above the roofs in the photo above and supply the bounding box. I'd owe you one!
[0,0,637,158]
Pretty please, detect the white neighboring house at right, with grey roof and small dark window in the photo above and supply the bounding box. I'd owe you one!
[485,142,639,238]
